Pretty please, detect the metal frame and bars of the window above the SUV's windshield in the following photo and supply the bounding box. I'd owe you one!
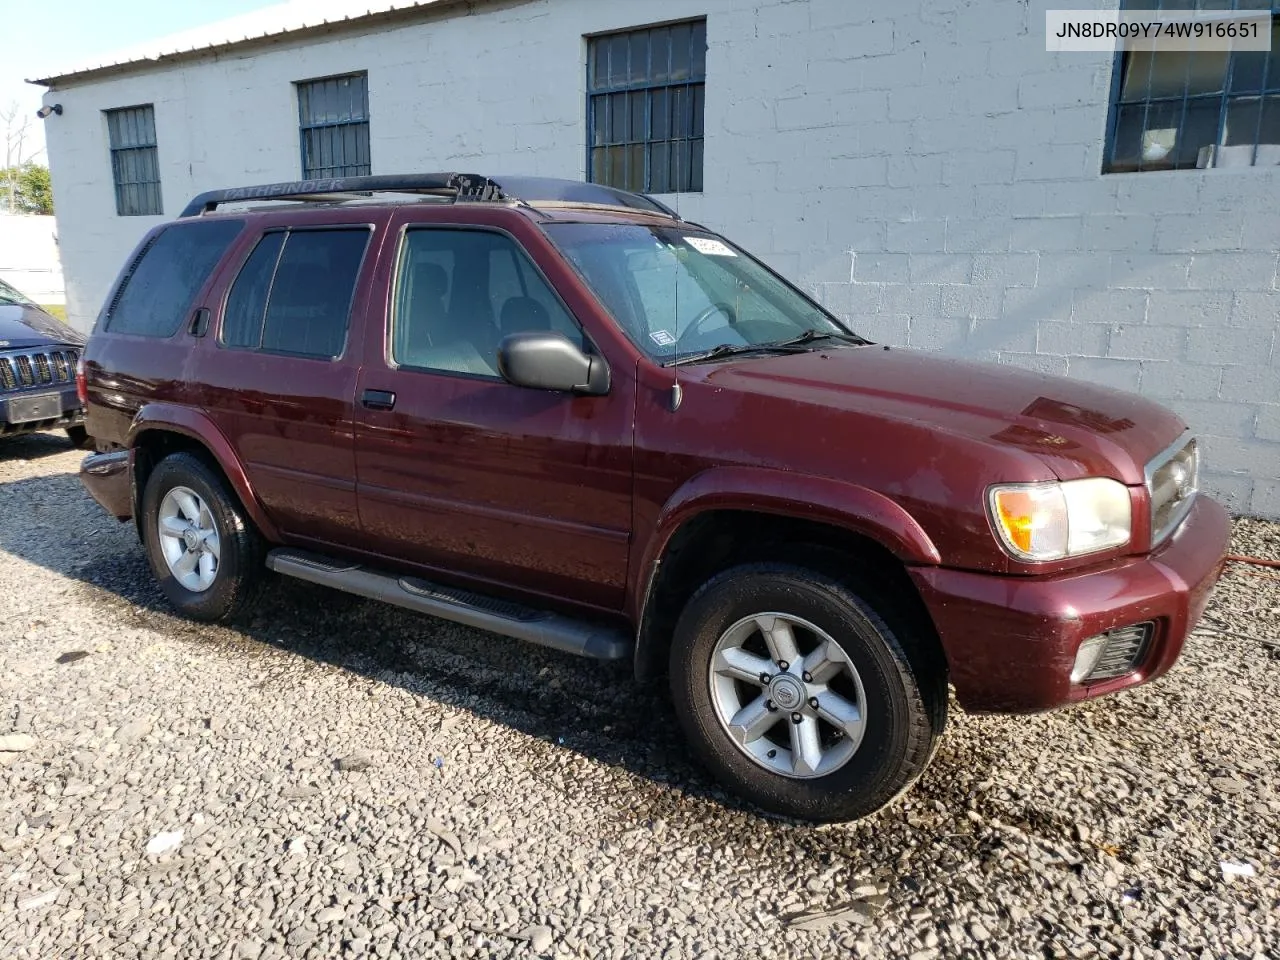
[582,15,709,195]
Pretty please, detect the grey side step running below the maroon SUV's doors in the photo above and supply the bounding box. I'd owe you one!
[266,549,632,660]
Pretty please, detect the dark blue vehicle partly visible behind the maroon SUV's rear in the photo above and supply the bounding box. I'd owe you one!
[0,280,88,447]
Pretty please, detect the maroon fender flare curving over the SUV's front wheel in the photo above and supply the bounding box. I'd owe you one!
[628,467,942,668]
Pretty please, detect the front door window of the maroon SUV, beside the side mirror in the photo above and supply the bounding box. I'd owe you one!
[392,228,582,379]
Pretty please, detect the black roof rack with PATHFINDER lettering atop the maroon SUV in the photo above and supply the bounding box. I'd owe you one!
[182,173,680,220]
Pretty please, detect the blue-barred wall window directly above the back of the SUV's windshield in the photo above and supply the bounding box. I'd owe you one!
[586,20,707,193]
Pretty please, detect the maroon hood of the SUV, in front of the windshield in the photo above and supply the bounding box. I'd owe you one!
[706,346,1187,484]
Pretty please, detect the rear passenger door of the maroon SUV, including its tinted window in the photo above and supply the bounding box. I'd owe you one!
[192,211,380,544]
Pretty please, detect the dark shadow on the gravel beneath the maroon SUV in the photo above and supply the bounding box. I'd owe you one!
[0,471,995,833]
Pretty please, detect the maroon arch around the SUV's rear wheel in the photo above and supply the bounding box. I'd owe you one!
[125,403,278,541]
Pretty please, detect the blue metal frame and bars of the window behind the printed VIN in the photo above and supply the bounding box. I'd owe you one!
[1102,0,1280,175]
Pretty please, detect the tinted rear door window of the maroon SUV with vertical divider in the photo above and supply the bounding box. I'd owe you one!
[221,227,370,360]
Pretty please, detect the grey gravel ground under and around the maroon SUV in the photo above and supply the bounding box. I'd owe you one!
[0,435,1280,960]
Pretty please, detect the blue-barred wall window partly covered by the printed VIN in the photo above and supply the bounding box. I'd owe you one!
[1103,0,1280,173]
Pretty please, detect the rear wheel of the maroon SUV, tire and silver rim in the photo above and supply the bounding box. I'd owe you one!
[142,453,264,622]
